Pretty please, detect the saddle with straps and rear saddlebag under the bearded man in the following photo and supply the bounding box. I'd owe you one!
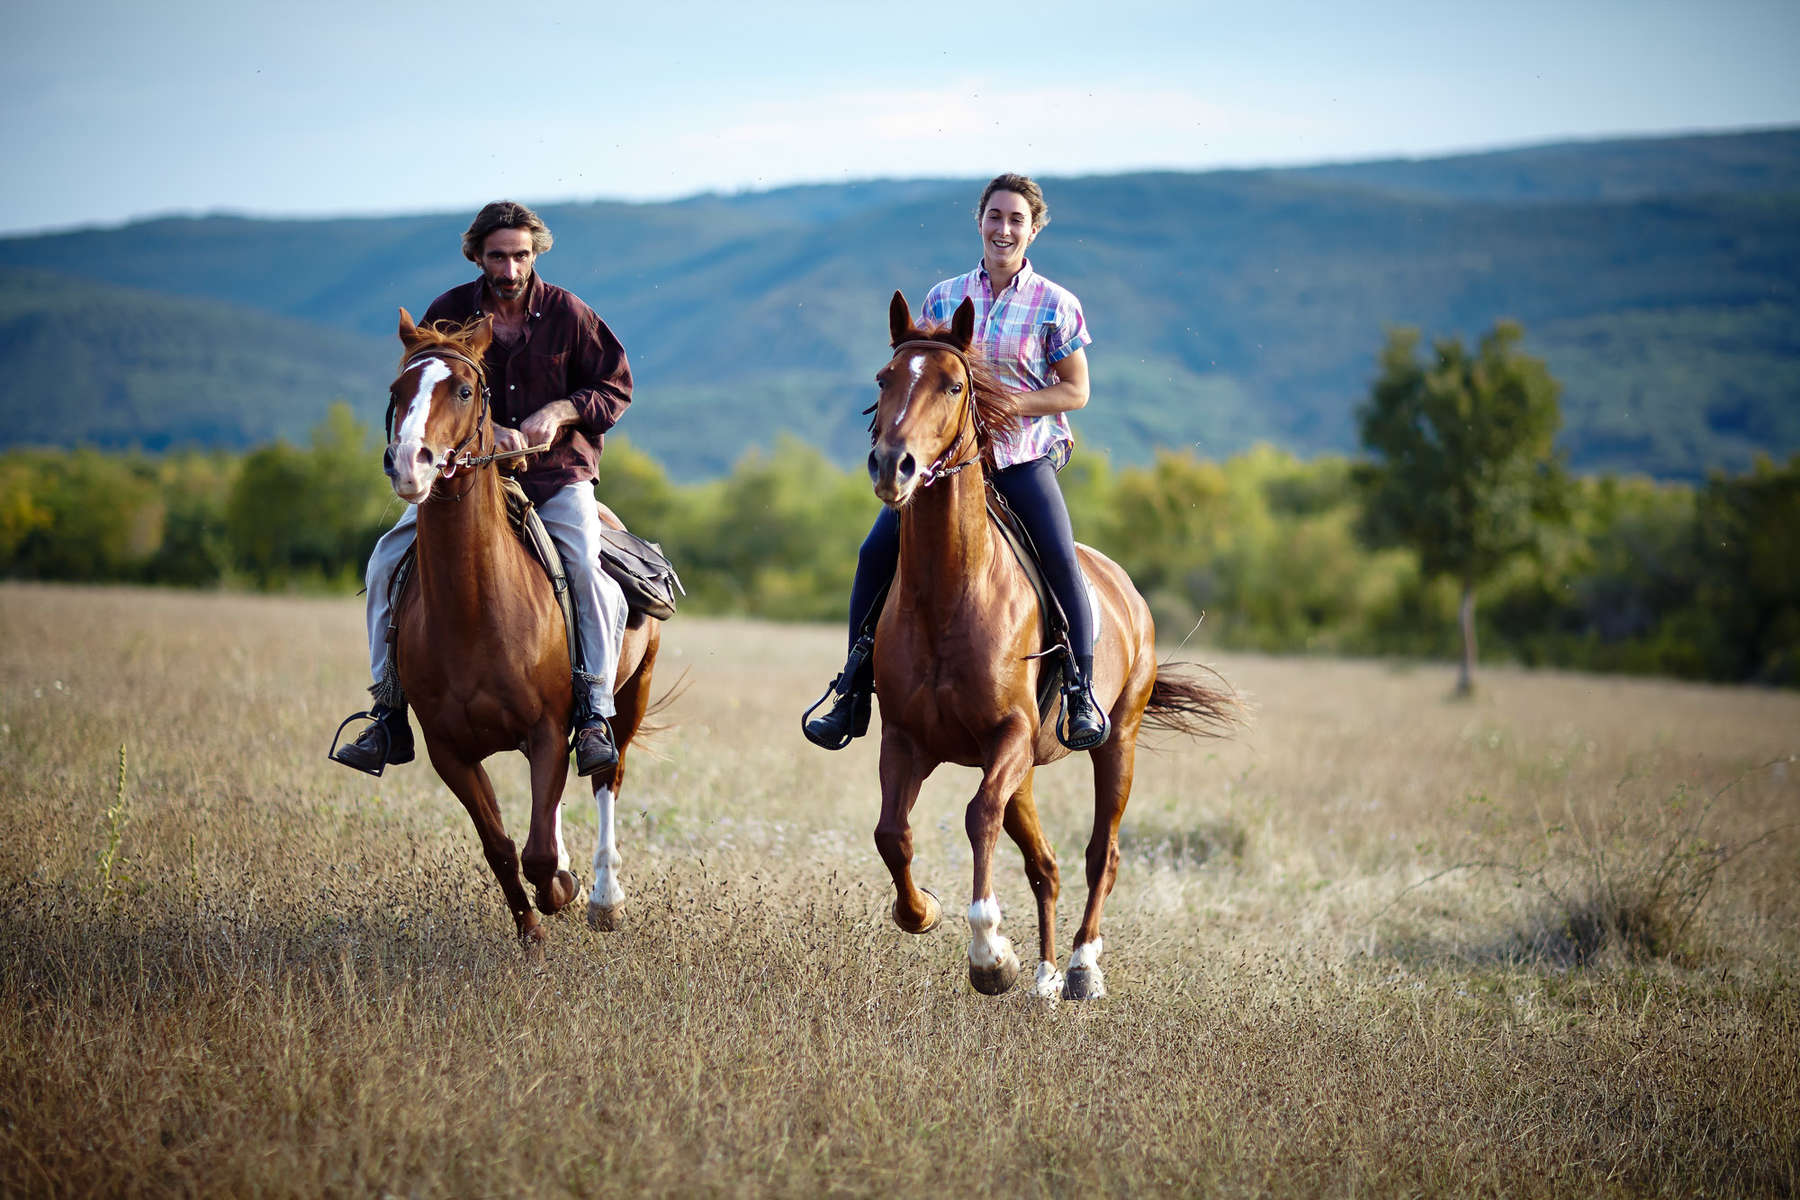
[374,477,688,705]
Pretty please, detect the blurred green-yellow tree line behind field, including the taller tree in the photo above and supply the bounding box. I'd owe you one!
[0,338,1800,685]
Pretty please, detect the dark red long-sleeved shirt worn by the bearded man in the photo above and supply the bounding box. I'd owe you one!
[425,272,632,504]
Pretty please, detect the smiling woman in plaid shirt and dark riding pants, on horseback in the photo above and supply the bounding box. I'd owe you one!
[805,175,1109,750]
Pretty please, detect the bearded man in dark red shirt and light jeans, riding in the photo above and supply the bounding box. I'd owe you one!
[333,200,632,775]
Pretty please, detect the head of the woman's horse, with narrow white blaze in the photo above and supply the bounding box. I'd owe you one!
[869,291,999,509]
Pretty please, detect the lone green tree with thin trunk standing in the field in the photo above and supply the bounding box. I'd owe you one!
[1357,320,1568,694]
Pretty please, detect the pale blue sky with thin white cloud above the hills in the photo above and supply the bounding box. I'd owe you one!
[0,0,1800,232]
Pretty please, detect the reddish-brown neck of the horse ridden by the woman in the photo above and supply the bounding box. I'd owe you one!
[896,461,994,615]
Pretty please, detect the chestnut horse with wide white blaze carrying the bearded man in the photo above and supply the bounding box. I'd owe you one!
[385,309,662,946]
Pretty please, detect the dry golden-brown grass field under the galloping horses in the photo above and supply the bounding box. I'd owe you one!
[0,585,1800,1196]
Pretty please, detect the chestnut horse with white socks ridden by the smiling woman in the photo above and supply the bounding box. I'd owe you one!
[869,291,1235,1000]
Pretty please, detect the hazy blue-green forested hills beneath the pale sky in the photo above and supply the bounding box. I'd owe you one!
[0,130,1800,479]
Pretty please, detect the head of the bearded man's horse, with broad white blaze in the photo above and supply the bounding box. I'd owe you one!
[382,309,493,504]
